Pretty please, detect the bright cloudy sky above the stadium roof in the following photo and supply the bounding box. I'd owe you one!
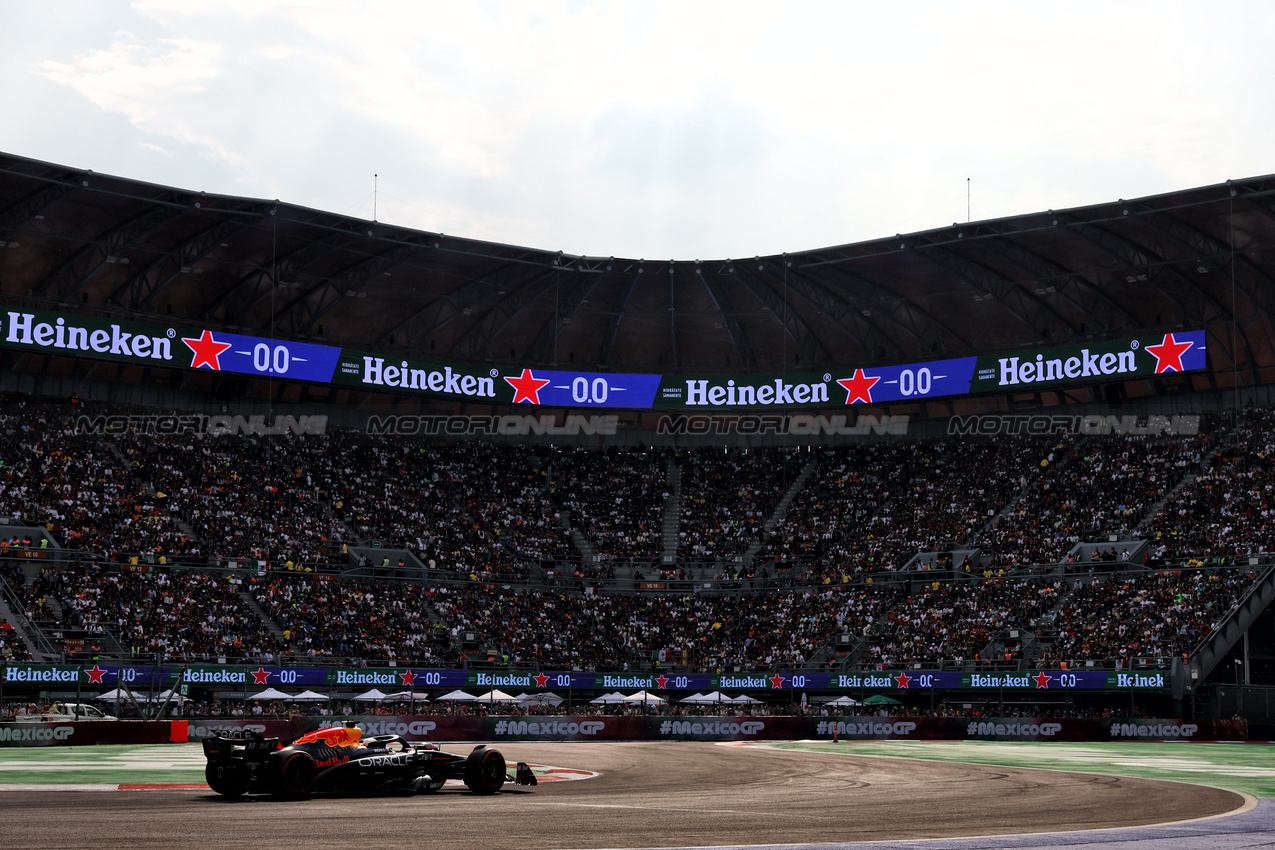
[0,0,1275,260]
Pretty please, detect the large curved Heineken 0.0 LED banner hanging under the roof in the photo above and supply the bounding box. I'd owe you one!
[0,308,1207,412]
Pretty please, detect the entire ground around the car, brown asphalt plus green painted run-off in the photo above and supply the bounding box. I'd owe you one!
[0,742,1275,850]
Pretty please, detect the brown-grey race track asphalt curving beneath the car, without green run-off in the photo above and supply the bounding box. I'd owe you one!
[0,742,1248,850]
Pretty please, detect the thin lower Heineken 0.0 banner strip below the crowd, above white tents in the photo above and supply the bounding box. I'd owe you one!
[0,663,1169,693]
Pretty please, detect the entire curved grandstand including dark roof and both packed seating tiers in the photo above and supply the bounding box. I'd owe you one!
[0,155,1275,723]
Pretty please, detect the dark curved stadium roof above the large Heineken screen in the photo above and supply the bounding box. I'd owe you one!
[0,154,1275,400]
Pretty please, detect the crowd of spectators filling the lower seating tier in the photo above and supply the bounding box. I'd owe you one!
[6,566,1256,672]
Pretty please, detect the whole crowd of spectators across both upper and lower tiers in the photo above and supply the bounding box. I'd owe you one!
[0,400,1275,670]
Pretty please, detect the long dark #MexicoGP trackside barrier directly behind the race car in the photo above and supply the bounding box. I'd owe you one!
[190,715,1248,742]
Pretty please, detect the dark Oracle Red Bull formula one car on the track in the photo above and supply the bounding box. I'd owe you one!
[204,726,536,799]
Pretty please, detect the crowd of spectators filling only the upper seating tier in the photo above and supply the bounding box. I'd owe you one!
[0,399,1275,582]
